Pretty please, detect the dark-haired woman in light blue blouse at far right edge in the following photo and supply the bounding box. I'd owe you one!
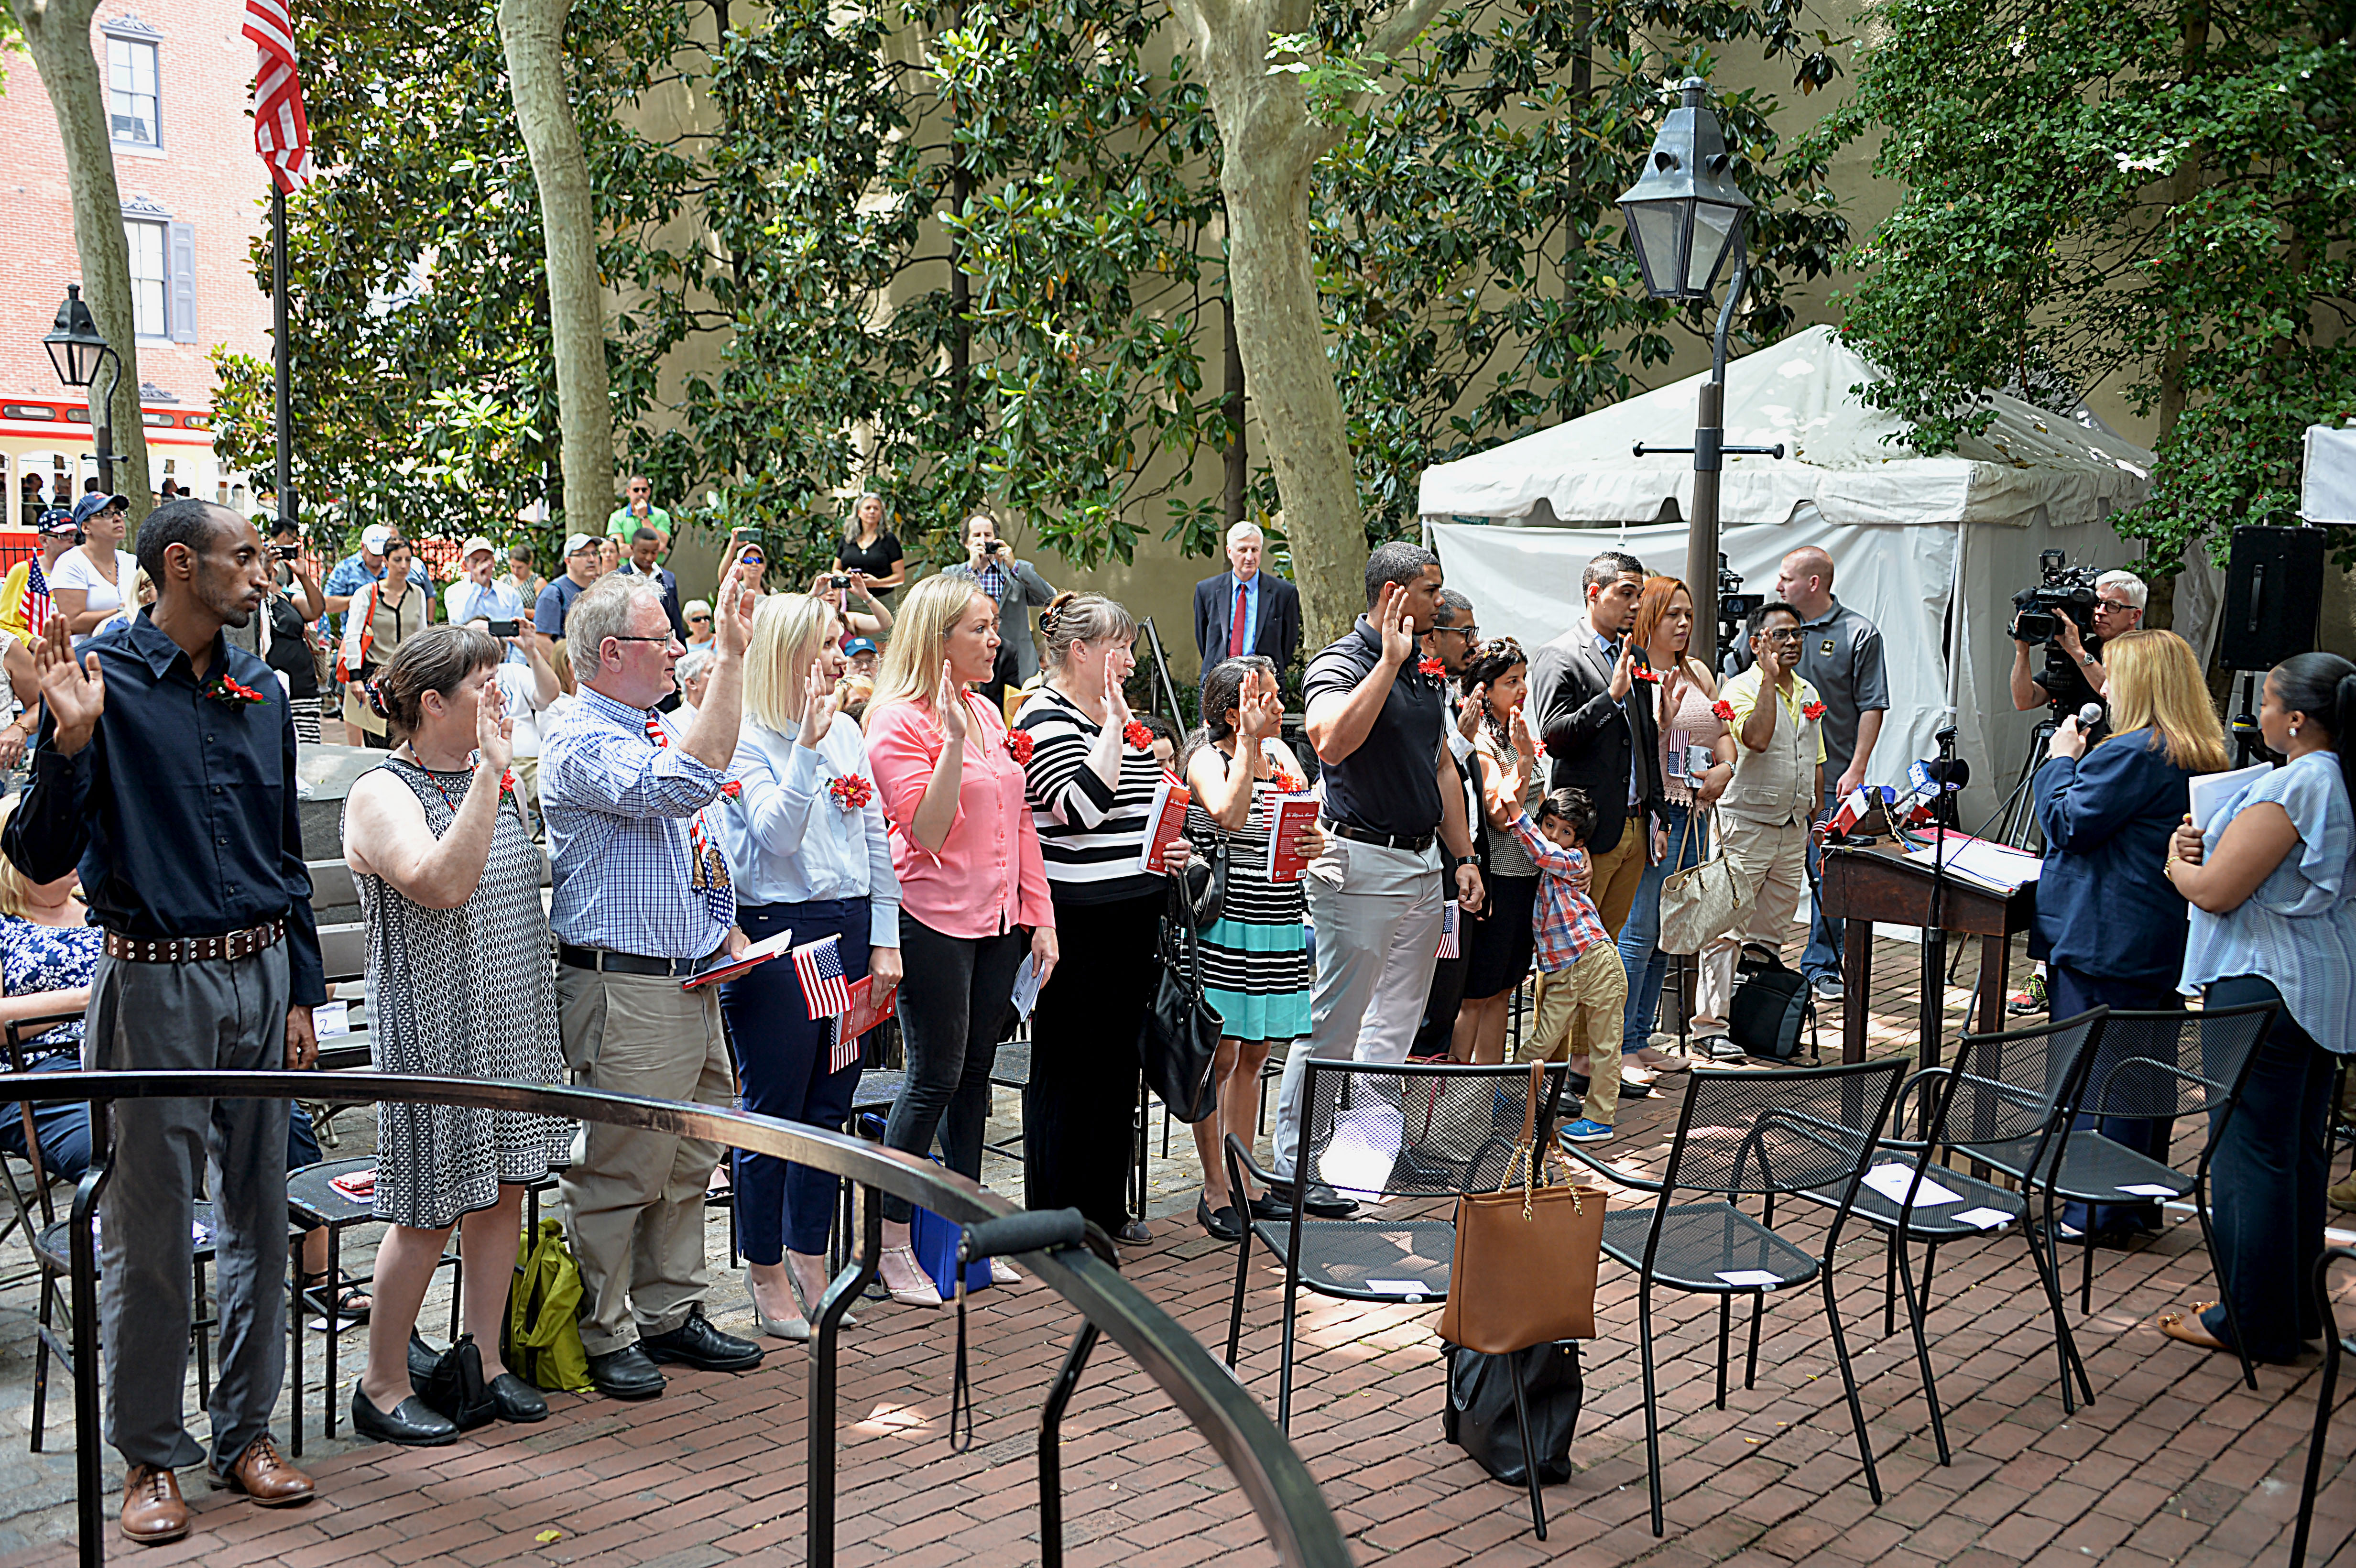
[2158,638,2356,1363]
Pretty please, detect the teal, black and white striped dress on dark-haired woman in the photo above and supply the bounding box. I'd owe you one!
[1185,739,1312,1041]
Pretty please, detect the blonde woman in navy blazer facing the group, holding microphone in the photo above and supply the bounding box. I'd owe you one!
[2029,631,2226,1236]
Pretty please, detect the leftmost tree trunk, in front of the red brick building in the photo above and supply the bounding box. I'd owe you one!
[10,0,148,518]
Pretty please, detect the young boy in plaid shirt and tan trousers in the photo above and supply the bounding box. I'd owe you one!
[1513,789,1628,1144]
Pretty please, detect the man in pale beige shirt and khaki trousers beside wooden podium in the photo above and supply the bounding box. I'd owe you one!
[1694,600,1823,1062]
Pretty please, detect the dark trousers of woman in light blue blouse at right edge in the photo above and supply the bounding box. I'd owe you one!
[2201,975,2337,1363]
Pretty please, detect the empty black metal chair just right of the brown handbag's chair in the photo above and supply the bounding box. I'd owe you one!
[1564,1062,1906,1535]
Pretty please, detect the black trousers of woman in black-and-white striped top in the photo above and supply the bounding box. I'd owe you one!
[1023,893,1168,1234]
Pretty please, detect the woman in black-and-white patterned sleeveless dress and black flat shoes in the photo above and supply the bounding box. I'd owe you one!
[344,626,573,1446]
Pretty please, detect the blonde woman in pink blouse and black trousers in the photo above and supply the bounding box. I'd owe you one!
[867,577,1056,1307]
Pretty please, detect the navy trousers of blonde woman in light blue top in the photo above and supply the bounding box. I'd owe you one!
[721,899,874,1264]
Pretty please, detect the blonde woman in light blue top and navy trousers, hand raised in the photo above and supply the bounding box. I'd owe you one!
[711,593,900,1339]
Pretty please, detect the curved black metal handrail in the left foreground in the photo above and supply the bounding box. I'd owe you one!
[0,1071,1350,1568]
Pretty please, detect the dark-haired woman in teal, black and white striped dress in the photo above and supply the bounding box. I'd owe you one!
[1185,654,1324,1241]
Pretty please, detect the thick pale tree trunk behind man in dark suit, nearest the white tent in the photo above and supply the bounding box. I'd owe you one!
[1176,0,1440,647]
